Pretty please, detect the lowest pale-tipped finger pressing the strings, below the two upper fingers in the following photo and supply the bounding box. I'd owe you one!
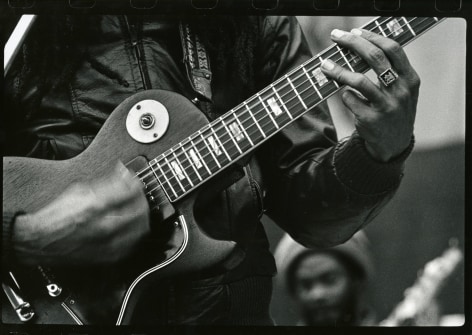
[321,59,383,102]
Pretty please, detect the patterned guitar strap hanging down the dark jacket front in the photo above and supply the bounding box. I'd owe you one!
[179,22,217,120]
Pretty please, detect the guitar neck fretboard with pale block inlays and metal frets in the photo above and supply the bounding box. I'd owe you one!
[149,17,442,201]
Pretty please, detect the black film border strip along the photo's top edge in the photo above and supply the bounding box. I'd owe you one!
[0,0,472,16]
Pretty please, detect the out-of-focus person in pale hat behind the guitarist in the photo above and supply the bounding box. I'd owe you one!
[275,231,375,326]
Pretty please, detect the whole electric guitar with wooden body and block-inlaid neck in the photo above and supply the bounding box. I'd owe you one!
[2,17,441,325]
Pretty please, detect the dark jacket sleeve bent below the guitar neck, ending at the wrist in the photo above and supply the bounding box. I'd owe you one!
[267,134,413,247]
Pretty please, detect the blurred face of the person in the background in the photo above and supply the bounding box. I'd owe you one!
[294,254,354,326]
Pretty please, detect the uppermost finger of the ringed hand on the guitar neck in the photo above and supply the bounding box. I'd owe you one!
[351,29,412,74]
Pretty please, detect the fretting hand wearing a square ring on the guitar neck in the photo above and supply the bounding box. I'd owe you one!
[322,29,420,162]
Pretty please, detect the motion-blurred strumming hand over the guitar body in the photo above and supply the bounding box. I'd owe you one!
[12,163,150,265]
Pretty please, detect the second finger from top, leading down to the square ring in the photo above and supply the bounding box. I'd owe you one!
[331,29,392,75]
